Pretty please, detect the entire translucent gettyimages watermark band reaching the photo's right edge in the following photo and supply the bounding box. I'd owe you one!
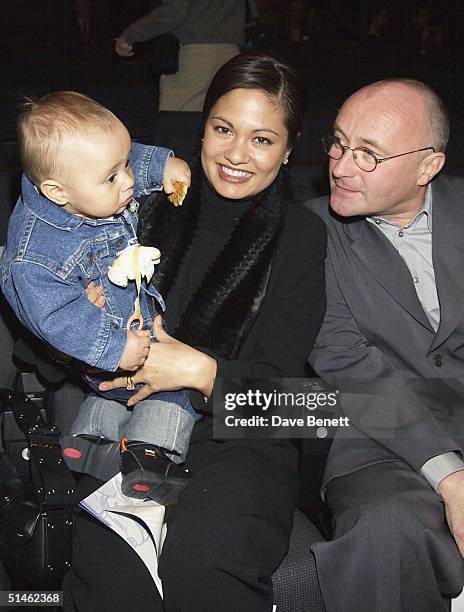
[213,377,464,443]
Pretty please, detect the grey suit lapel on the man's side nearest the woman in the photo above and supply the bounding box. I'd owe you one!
[344,219,433,331]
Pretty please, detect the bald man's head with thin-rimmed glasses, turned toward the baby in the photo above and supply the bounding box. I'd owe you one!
[329,79,449,226]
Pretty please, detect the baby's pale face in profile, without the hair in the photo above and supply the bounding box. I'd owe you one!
[61,122,134,218]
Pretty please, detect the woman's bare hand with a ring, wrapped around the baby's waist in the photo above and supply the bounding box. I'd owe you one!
[99,315,217,406]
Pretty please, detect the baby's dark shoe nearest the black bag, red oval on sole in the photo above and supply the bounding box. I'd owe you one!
[60,434,120,482]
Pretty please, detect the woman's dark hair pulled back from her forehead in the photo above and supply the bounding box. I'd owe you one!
[203,53,303,148]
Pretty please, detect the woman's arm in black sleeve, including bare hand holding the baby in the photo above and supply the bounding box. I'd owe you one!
[100,209,325,405]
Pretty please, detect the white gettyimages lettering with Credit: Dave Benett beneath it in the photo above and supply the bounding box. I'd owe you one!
[213,378,349,438]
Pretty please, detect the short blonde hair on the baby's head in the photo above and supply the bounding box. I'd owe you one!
[18,91,120,186]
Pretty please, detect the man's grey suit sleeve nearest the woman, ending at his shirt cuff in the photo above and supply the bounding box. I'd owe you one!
[309,246,459,471]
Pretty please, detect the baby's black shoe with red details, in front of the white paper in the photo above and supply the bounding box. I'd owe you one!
[121,438,192,505]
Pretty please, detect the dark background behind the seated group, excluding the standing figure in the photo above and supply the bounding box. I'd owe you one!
[0,0,464,237]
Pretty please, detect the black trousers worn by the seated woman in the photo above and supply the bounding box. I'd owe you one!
[63,423,297,612]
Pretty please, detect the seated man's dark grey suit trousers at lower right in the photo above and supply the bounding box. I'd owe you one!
[312,461,464,612]
